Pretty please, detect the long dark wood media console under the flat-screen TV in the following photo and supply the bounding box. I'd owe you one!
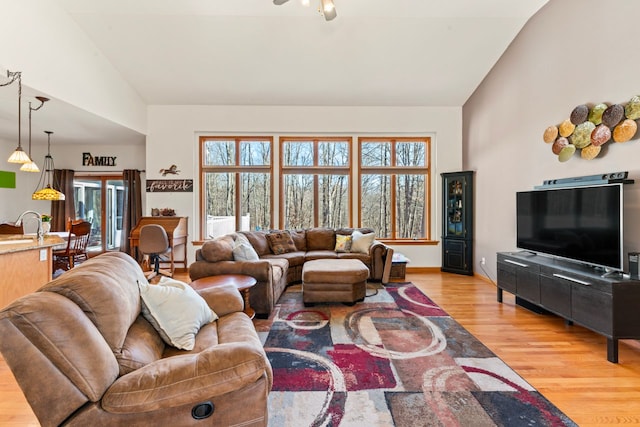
[497,252,640,363]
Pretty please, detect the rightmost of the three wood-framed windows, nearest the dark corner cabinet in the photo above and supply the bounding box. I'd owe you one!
[358,137,431,242]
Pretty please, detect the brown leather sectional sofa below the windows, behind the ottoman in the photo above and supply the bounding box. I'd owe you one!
[189,227,393,317]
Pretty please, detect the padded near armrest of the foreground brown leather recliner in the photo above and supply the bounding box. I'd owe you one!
[102,342,269,414]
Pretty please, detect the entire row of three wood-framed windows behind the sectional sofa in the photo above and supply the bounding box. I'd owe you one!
[200,136,431,244]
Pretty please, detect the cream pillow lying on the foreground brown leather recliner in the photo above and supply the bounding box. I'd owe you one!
[138,277,218,350]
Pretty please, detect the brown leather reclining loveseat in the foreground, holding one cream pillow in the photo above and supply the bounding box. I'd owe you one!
[0,253,272,426]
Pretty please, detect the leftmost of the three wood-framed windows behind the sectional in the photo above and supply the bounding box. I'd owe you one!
[200,137,273,239]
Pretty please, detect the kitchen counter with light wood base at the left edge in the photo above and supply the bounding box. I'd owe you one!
[0,235,66,307]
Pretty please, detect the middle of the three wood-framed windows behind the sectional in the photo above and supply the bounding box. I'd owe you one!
[280,137,352,229]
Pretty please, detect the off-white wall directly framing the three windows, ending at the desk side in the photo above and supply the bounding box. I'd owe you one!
[146,106,462,267]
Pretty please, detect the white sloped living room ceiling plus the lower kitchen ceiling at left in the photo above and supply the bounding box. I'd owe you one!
[0,0,548,143]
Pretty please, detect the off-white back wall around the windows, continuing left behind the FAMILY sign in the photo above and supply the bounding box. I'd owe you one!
[0,106,462,267]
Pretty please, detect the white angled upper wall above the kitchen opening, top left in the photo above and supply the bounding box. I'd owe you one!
[0,0,146,134]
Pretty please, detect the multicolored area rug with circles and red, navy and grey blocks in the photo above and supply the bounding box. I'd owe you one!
[256,283,576,427]
